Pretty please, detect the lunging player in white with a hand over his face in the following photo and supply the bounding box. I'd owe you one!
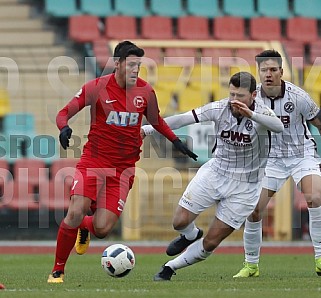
[143,72,283,281]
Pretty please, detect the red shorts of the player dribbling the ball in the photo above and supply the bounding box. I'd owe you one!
[70,165,135,216]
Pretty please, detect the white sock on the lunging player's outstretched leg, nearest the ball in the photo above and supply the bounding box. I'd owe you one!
[165,238,212,271]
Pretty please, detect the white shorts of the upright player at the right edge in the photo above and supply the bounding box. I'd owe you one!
[262,156,321,192]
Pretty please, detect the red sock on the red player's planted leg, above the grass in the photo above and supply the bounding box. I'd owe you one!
[52,220,78,271]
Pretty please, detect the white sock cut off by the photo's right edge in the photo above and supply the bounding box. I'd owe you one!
[308,207,321,259]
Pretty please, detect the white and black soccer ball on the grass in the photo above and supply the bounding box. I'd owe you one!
[101,244,135,277]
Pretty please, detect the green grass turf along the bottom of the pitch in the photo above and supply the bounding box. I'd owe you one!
[0,254,321,298]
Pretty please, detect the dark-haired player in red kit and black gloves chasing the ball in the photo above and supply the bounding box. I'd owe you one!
[48,41,197,283]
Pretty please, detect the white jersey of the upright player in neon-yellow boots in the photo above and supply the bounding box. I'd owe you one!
[257,81,319,158]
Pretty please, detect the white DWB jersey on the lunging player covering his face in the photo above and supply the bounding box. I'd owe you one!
[193,98,275,182]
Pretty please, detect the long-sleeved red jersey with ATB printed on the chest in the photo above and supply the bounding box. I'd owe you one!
[56,74,177,168]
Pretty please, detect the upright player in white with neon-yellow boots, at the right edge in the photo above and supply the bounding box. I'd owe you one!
[234,50,321,278]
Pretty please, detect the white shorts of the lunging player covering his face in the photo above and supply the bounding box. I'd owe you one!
[179,163,262,229]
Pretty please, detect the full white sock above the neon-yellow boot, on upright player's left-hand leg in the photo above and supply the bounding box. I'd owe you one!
[243,220,262,264]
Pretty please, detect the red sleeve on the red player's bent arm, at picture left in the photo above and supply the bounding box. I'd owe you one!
[56,81,95,130]
